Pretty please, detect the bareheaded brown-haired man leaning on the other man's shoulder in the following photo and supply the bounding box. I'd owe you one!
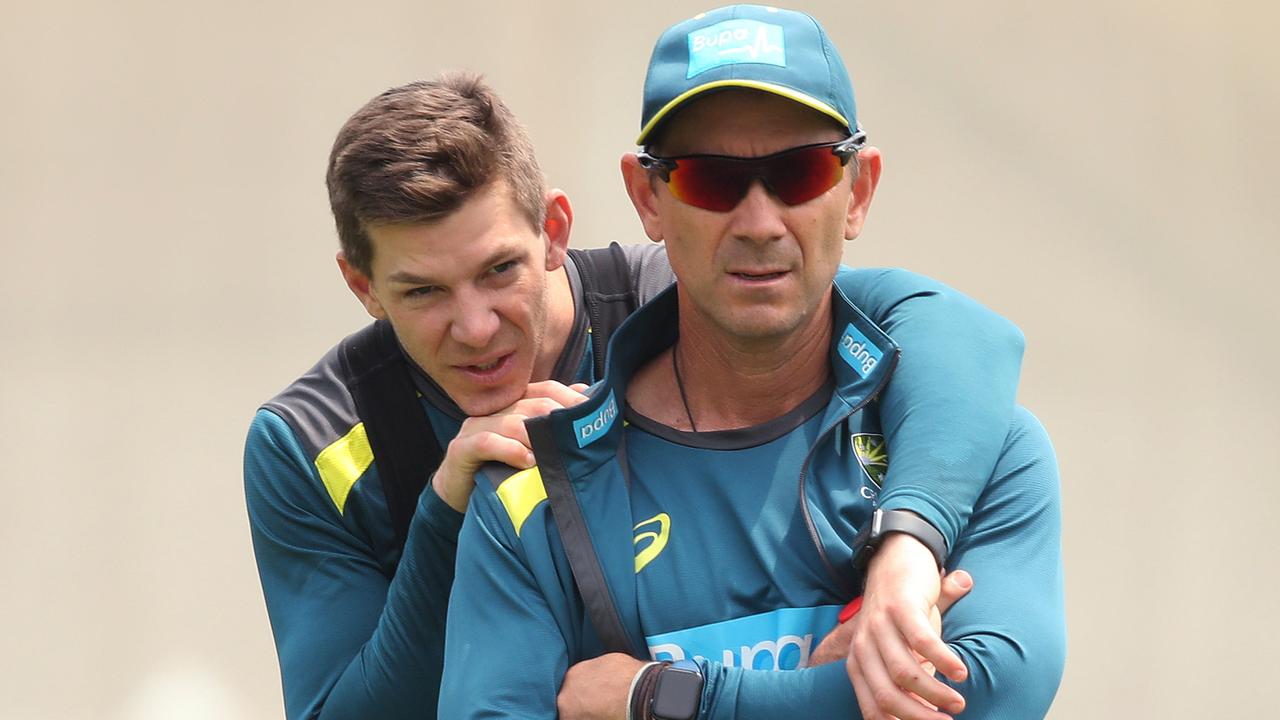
[244,68,1021,720]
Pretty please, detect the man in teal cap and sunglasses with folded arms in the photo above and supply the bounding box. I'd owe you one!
[439,5,1065,720]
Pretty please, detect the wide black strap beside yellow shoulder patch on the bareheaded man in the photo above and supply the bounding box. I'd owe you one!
[339,320,444,556]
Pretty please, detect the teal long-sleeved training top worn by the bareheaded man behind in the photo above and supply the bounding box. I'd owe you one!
[244,246,1023,720]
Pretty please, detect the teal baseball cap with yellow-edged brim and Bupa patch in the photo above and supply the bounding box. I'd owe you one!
[636,5,858,146]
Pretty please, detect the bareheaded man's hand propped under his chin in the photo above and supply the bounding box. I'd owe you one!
[431,380,586,512]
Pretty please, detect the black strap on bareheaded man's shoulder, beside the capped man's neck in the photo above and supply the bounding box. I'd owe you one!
[568,242,640,378]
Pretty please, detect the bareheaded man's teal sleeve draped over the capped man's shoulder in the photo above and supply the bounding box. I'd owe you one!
[841,270,1024,547]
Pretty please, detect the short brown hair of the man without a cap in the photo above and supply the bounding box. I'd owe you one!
[325,72,547,275]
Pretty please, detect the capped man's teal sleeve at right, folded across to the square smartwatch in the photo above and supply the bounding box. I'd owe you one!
[704,410,1066,720]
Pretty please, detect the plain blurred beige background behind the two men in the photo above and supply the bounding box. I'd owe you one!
[0,0,1280,720]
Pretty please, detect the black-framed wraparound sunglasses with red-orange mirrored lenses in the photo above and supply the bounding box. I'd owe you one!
[636,132,867,213]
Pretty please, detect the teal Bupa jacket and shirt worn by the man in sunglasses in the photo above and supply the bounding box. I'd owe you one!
[439,273,1065,720]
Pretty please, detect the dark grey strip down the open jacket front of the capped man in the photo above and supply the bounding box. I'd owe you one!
[525,418,640,657]
